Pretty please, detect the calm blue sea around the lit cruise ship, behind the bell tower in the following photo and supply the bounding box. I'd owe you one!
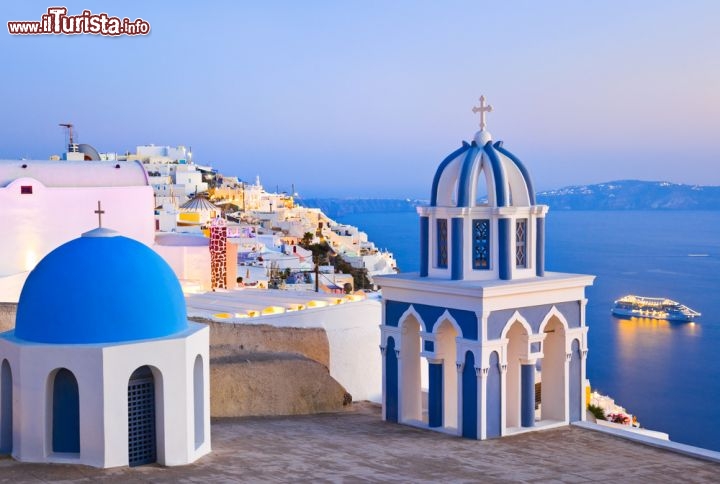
[341,211,720,451]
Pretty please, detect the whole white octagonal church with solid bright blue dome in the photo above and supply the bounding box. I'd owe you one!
[0,221,210,467]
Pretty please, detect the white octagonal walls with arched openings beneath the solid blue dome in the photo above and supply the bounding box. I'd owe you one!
[0,324,211,467]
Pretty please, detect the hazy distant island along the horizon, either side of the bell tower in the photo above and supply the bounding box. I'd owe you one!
[299,180,720,218]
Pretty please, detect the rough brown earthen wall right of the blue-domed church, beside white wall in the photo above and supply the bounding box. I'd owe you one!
[190,318,352,417]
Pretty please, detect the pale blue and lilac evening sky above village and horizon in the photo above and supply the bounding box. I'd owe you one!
[0,0,720,197]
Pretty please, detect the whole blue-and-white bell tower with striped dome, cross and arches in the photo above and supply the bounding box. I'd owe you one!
[377,97,593,439]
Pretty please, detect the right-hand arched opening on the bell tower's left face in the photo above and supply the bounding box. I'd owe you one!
[430,319,458,429]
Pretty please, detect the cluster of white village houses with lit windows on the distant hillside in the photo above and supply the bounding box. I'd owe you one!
[123,145,397,293]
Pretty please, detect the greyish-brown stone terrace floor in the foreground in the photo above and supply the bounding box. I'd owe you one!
[0,404,720,483]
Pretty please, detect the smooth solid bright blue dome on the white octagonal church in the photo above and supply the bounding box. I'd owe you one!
[15,229,188,344]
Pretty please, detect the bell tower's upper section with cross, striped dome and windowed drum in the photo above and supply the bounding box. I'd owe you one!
[418,96,547,280]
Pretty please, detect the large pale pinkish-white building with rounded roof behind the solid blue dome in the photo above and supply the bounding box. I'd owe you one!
[0,160,155,302]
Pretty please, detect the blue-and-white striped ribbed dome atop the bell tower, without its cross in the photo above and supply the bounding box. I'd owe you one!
[430,131,536,207]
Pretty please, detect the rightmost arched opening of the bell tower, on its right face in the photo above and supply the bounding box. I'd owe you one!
[540,316,567,422]
